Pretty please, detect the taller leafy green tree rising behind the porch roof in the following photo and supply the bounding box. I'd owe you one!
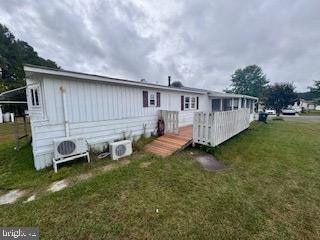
[227,65,269,98]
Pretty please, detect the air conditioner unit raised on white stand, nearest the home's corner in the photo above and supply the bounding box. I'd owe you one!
[53,137,90,172]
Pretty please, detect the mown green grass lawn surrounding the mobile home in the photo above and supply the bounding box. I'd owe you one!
[0,121,320,240]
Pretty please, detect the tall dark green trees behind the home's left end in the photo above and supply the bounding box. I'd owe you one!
[0,24,58,92]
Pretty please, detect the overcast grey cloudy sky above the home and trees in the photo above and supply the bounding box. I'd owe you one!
[0,0,320,91]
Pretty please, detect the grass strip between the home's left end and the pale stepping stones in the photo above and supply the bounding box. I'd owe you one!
[0,138,152,191]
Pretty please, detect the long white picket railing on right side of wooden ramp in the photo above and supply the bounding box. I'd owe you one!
[193,109,250,146]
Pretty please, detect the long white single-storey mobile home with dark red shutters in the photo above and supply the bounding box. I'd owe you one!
[24,65,257,169]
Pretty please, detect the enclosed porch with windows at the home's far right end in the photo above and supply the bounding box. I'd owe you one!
[209,92,258,122]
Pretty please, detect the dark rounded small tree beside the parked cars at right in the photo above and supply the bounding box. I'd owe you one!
[264,83,297,116]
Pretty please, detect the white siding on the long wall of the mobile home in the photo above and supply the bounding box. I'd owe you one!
[27,78,208,169]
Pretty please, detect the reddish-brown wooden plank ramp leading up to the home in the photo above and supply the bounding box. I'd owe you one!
[144,125,192,157]
